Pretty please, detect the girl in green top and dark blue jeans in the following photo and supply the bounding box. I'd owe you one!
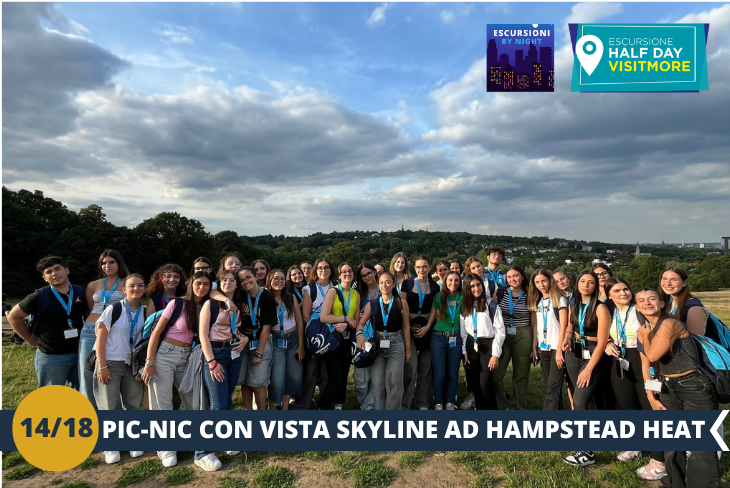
[426,271,462,410]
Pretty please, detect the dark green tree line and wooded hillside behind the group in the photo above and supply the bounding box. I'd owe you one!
[2,187,730,296]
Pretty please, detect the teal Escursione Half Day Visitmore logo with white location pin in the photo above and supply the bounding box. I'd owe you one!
[568,24,710,93]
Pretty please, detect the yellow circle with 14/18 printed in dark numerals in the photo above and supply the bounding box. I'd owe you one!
[13,386,99,471]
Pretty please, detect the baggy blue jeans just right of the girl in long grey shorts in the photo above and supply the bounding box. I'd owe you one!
[269,330,302,406]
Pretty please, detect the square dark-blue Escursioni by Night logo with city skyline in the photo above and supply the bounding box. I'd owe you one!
[487,24,555,92]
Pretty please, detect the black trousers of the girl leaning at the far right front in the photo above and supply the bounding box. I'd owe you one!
[660,371,720,488]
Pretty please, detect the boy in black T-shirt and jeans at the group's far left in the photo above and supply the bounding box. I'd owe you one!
[8,256,88,388]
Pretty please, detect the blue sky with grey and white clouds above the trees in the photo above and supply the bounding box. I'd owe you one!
[2,3,730,242]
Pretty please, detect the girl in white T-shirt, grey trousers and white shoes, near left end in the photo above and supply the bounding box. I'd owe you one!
[94,274,144,464]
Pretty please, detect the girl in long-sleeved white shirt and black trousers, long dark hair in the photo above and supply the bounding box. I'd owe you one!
[459,274,506,410]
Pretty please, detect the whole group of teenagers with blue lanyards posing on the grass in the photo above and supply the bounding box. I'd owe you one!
[8,248,720,487]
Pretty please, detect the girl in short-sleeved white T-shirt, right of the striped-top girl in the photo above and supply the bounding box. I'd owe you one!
[527,269,568,410]
